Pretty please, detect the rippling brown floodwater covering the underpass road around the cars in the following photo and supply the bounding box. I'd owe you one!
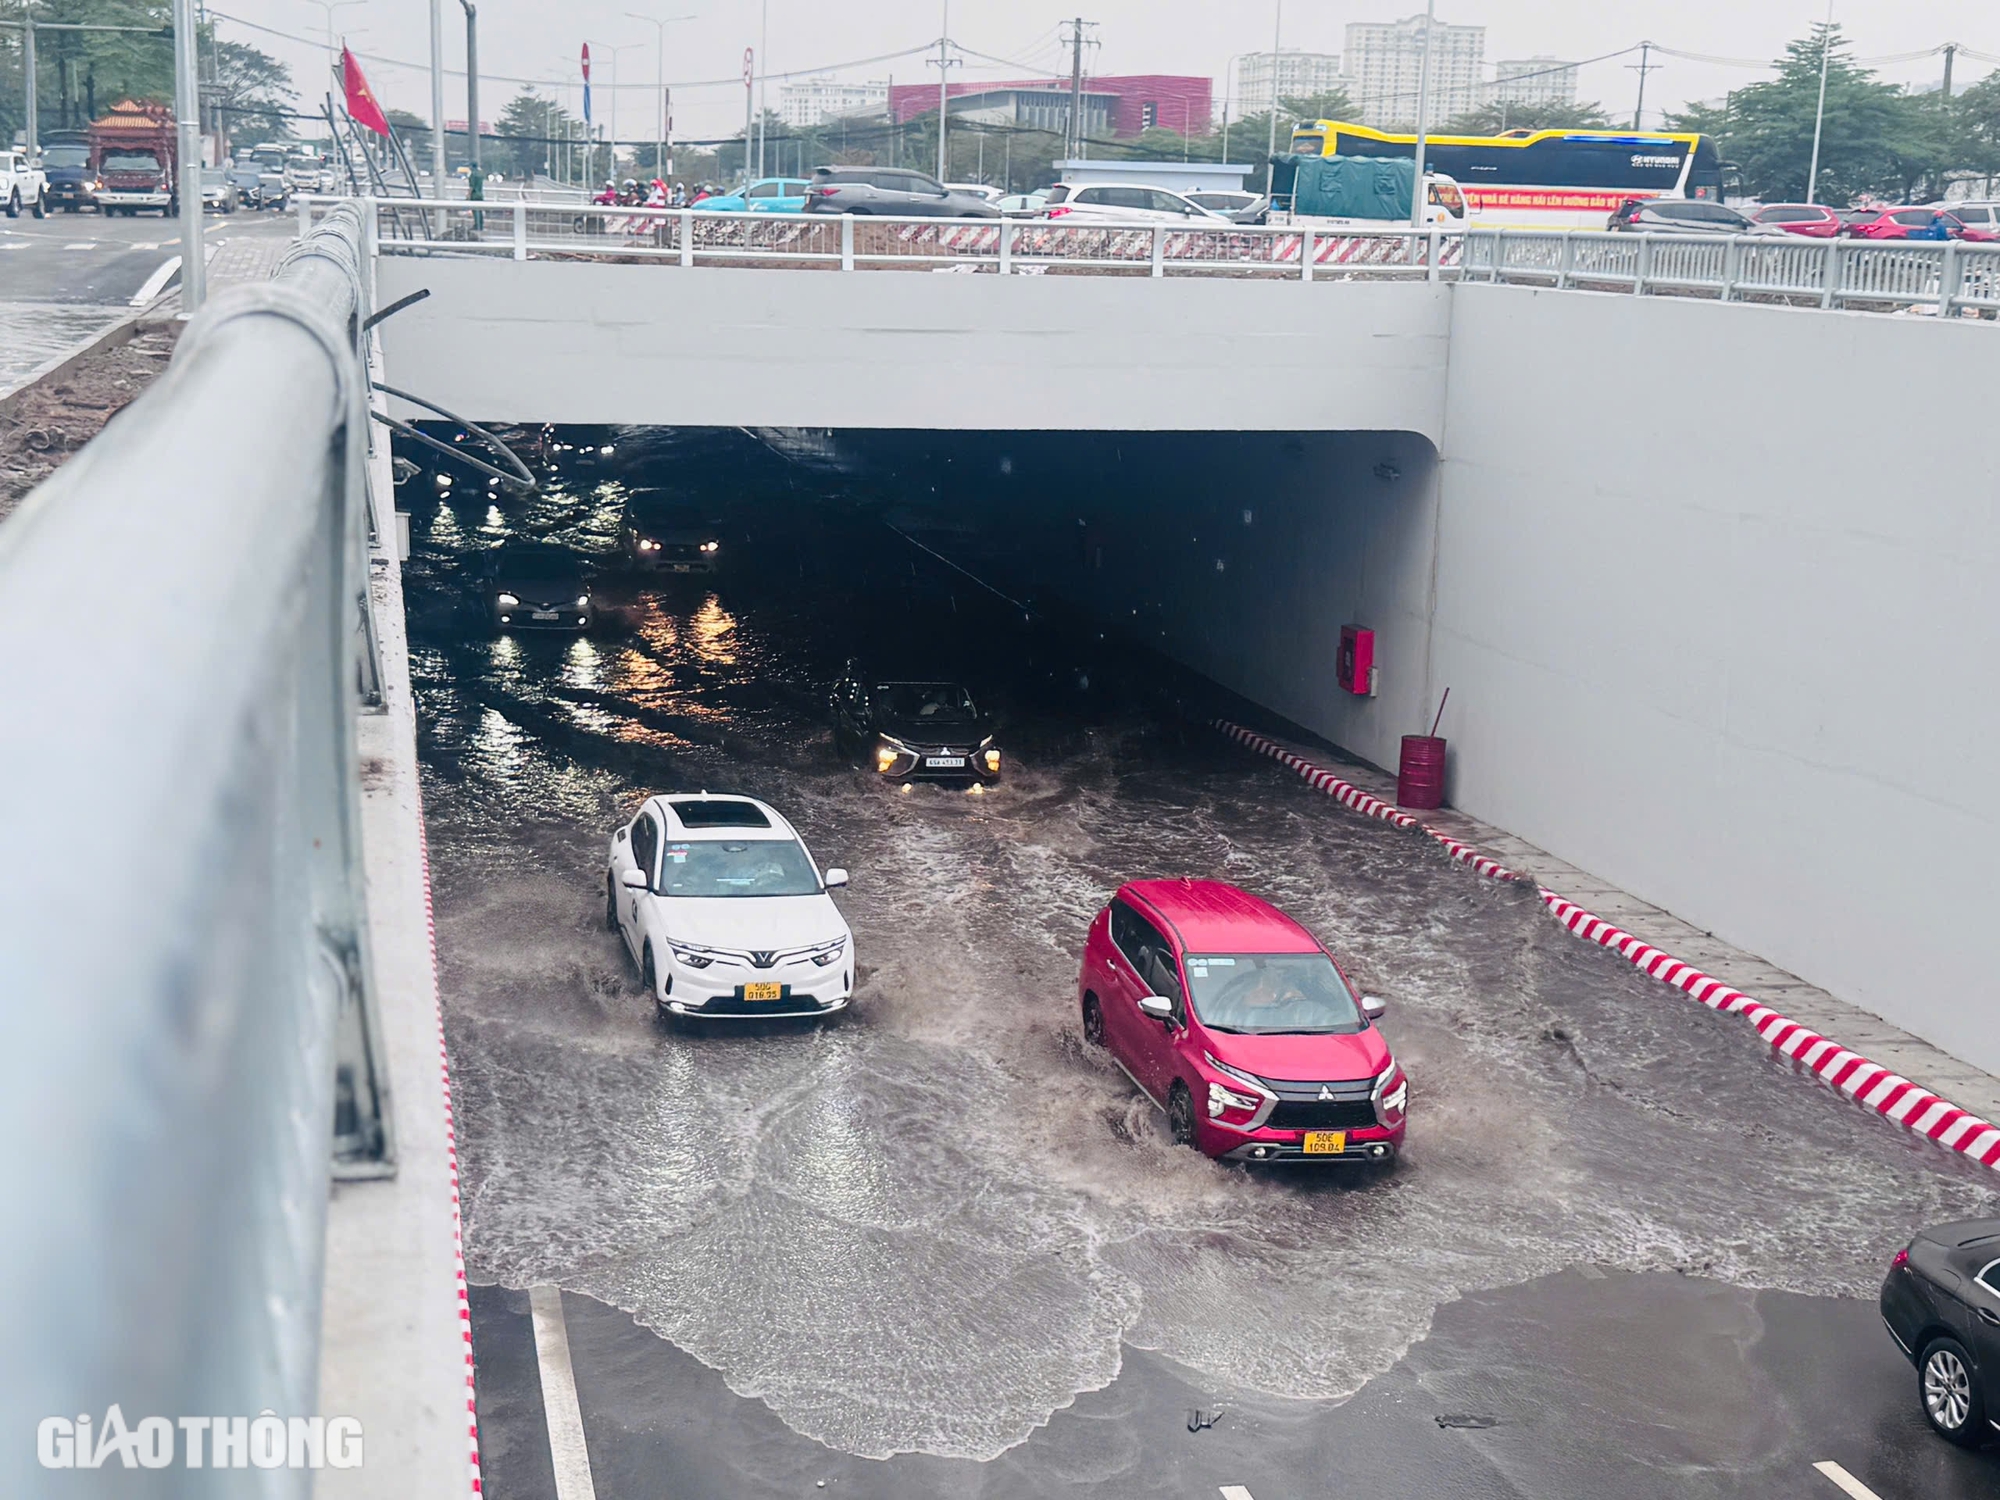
[406,432,1994,1458]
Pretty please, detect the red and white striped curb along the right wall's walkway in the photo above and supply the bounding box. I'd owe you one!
[1210,718,2000,1168]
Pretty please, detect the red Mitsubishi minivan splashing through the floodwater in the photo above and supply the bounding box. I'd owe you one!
[1076,878,1410,1166]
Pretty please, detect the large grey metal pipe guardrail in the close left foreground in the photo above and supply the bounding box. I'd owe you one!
[0,204,380,1496]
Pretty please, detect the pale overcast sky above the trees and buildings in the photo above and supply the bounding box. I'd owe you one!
[223,0,2000,140]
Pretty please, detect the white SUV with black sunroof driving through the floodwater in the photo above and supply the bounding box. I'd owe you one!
[604,792,854,1022]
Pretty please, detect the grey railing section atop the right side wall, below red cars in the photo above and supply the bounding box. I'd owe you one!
[1460,230,2000,318]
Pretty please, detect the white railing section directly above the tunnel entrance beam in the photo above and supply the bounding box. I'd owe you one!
[298,198,1460,280]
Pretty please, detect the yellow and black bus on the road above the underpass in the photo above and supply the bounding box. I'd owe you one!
[1292,120,1722,230]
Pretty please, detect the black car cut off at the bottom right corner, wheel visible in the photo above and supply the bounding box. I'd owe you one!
[1882,1218,2000,1448]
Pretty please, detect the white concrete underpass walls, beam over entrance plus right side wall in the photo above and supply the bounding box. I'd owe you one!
[380,258,2000,1070]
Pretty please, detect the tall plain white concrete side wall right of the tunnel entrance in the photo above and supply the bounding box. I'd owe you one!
[1432,286,2000,1072]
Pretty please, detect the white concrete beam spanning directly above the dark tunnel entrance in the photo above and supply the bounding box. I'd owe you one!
[378,256,1450,438]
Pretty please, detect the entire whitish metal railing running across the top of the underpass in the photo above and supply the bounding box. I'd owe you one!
[298,198,2000,318]
